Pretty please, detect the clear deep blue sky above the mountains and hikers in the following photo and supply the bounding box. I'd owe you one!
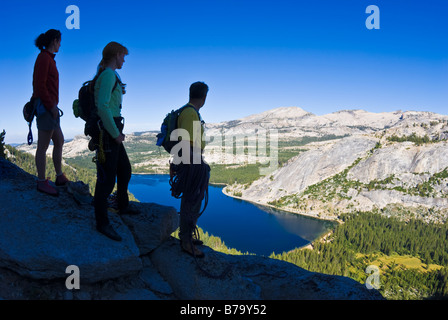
[0,0,448,143]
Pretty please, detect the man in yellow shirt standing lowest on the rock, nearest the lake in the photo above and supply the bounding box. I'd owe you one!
[170,82,210,258]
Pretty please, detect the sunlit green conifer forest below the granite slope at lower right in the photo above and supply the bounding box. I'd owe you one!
[271,212,448,299]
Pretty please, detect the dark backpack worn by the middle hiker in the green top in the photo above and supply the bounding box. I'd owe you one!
[73,75,118,136]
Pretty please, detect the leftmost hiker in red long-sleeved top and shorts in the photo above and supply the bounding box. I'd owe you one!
[32,29,68,196]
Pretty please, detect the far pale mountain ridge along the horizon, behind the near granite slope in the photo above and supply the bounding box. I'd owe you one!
[17,107,448,163]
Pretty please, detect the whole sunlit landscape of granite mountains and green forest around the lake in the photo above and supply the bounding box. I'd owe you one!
[7,107,448,299]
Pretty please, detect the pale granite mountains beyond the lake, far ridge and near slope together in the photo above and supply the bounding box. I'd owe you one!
[18,107,448,222]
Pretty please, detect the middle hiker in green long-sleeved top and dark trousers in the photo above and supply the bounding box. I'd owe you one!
[94,42,136,241]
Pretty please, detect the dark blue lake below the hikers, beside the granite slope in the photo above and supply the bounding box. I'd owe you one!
[129,175,333,256]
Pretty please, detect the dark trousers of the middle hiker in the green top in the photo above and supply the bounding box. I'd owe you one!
[94,140,132,226]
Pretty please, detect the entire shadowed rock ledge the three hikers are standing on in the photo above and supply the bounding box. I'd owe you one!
[0,158,382,300]
